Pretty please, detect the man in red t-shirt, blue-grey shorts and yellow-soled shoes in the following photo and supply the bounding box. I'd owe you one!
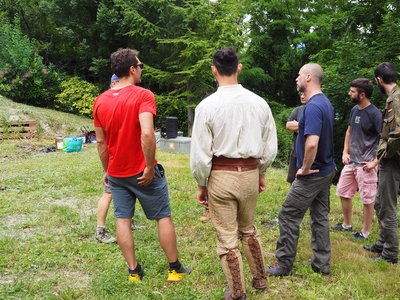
[93,49,190,283]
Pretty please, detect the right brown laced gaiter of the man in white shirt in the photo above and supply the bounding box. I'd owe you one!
[242,231,267,290]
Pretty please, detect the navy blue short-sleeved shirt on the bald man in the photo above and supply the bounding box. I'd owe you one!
[296,93,335,176]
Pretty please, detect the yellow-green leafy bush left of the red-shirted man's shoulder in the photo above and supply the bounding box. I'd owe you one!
[55,77,100,117]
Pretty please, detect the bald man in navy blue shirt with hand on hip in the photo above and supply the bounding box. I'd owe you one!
[267,64,335,276]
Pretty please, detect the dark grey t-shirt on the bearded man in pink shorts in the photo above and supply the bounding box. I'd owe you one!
[349,104,382,165]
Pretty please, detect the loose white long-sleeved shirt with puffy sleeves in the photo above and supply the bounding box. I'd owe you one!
[190,84,278,186]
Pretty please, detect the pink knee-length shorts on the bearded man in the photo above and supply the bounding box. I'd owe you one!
[336,165,378,204]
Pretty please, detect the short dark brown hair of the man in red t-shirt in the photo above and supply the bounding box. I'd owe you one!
[111,48,139,78]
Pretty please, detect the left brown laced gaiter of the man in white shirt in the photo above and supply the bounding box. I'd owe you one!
[220,249,246,299]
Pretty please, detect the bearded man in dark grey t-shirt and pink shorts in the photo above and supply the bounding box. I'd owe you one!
[332,78,382,240]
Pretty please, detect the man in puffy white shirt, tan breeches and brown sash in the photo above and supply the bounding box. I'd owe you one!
[190,48,277,299]
